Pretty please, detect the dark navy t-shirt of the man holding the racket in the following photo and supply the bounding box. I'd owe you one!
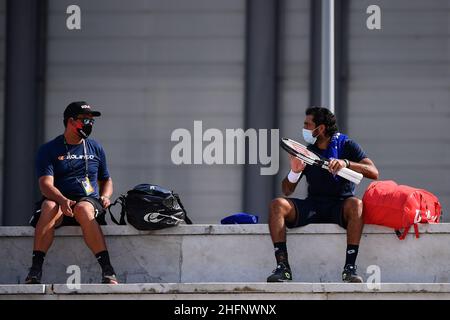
[303,139,367,199]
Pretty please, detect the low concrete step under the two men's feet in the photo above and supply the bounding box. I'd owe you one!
[0,283,450,300]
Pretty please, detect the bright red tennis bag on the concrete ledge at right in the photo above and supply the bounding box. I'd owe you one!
[362,180,441,240]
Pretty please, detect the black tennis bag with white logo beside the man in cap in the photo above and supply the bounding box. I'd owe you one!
[108,184,192,230]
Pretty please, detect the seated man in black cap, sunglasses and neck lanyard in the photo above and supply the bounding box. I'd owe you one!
[25,101,117,284]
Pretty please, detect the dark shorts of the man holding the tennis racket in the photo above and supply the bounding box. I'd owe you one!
[286,198,347,229]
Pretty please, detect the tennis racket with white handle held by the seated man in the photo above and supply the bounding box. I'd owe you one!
[280,138,363,184]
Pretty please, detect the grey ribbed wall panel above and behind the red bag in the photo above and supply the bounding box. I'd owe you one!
[348,0,450,221]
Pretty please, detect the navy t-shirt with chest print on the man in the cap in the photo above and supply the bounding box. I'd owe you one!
[36,135,110,198]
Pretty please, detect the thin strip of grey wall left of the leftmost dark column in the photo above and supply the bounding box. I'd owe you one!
[0,0,6,225]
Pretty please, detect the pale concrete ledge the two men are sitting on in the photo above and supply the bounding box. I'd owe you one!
[0,223,450,284]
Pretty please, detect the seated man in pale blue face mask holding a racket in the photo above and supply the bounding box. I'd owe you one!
[267,107,378,282]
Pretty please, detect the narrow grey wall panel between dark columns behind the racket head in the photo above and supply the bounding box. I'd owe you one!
[277,0,311,197]
